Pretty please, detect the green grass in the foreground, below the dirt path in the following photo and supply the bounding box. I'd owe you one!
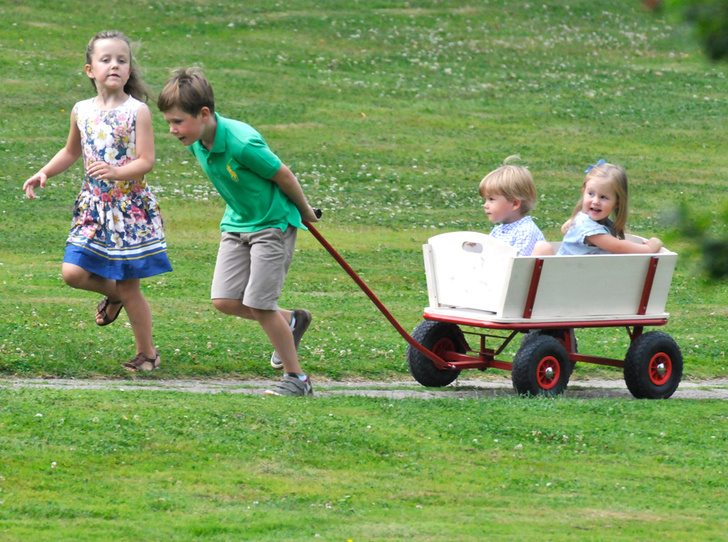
[0,389,728,542]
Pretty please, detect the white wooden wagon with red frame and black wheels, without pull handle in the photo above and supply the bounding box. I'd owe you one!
[407,232,683,399]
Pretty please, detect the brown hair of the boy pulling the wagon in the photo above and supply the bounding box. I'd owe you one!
[157,68,215,116]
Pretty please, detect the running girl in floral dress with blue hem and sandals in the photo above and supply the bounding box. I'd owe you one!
[23,31,172,371]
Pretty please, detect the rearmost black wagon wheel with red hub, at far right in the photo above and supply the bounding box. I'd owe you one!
[624,331,683,399]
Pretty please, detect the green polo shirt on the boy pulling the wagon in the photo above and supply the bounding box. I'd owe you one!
[190,113,305,232]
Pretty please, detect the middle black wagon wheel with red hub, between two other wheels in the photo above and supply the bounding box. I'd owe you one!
[511,334,573,397]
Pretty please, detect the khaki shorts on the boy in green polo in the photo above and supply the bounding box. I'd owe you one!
[211,226,298,310]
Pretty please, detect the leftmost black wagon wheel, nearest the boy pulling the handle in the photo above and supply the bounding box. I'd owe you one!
[407,321,465,388]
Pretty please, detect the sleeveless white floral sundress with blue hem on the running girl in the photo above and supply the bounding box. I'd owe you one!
[63,96,172,280]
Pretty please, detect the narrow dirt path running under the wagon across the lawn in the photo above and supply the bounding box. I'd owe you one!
[0,378,728,400]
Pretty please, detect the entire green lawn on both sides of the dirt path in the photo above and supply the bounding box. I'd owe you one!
[0,0,728,541]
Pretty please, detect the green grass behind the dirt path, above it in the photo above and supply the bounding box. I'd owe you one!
[0,0,728,379]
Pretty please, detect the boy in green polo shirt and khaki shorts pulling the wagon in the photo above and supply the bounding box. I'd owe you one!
[157,68,318,395]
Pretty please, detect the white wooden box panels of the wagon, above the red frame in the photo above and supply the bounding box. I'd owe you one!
[424,232,677,322]
